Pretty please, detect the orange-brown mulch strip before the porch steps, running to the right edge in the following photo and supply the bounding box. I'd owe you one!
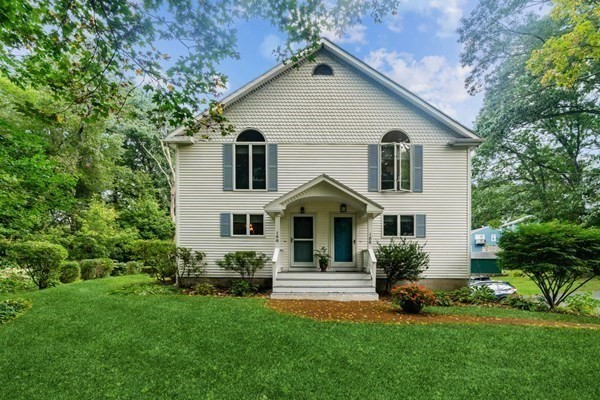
[267,300,600,329]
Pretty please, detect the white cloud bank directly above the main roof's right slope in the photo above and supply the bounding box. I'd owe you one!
[365,48,482,126]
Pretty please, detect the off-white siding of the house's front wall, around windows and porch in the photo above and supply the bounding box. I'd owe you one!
[177,50,470,278]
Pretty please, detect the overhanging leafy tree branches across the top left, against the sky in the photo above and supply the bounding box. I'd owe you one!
[0,0,397,133]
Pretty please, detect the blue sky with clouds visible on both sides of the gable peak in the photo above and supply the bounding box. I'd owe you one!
[213,0,482,127]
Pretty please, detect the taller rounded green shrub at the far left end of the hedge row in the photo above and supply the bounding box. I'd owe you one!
[8,241,68,289]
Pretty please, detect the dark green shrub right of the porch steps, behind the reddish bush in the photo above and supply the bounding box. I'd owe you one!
[375,238,429,291]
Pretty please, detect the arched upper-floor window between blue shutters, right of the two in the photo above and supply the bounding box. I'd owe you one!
[380,131,411,191]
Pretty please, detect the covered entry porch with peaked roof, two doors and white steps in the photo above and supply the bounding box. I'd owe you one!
[265,174,383,300]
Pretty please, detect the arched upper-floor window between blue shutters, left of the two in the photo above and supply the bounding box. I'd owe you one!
[235,129,267,190]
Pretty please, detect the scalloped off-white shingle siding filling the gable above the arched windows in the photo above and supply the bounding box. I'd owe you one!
[209,51,458,144]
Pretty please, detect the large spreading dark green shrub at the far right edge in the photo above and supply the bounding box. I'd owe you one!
[498,222,600,309]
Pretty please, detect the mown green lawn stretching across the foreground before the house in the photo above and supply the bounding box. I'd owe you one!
[0,276,600,400]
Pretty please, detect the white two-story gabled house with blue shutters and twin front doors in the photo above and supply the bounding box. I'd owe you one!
[166,39,482,300]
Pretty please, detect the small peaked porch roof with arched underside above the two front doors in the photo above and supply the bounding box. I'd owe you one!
[265,174,383,216]
